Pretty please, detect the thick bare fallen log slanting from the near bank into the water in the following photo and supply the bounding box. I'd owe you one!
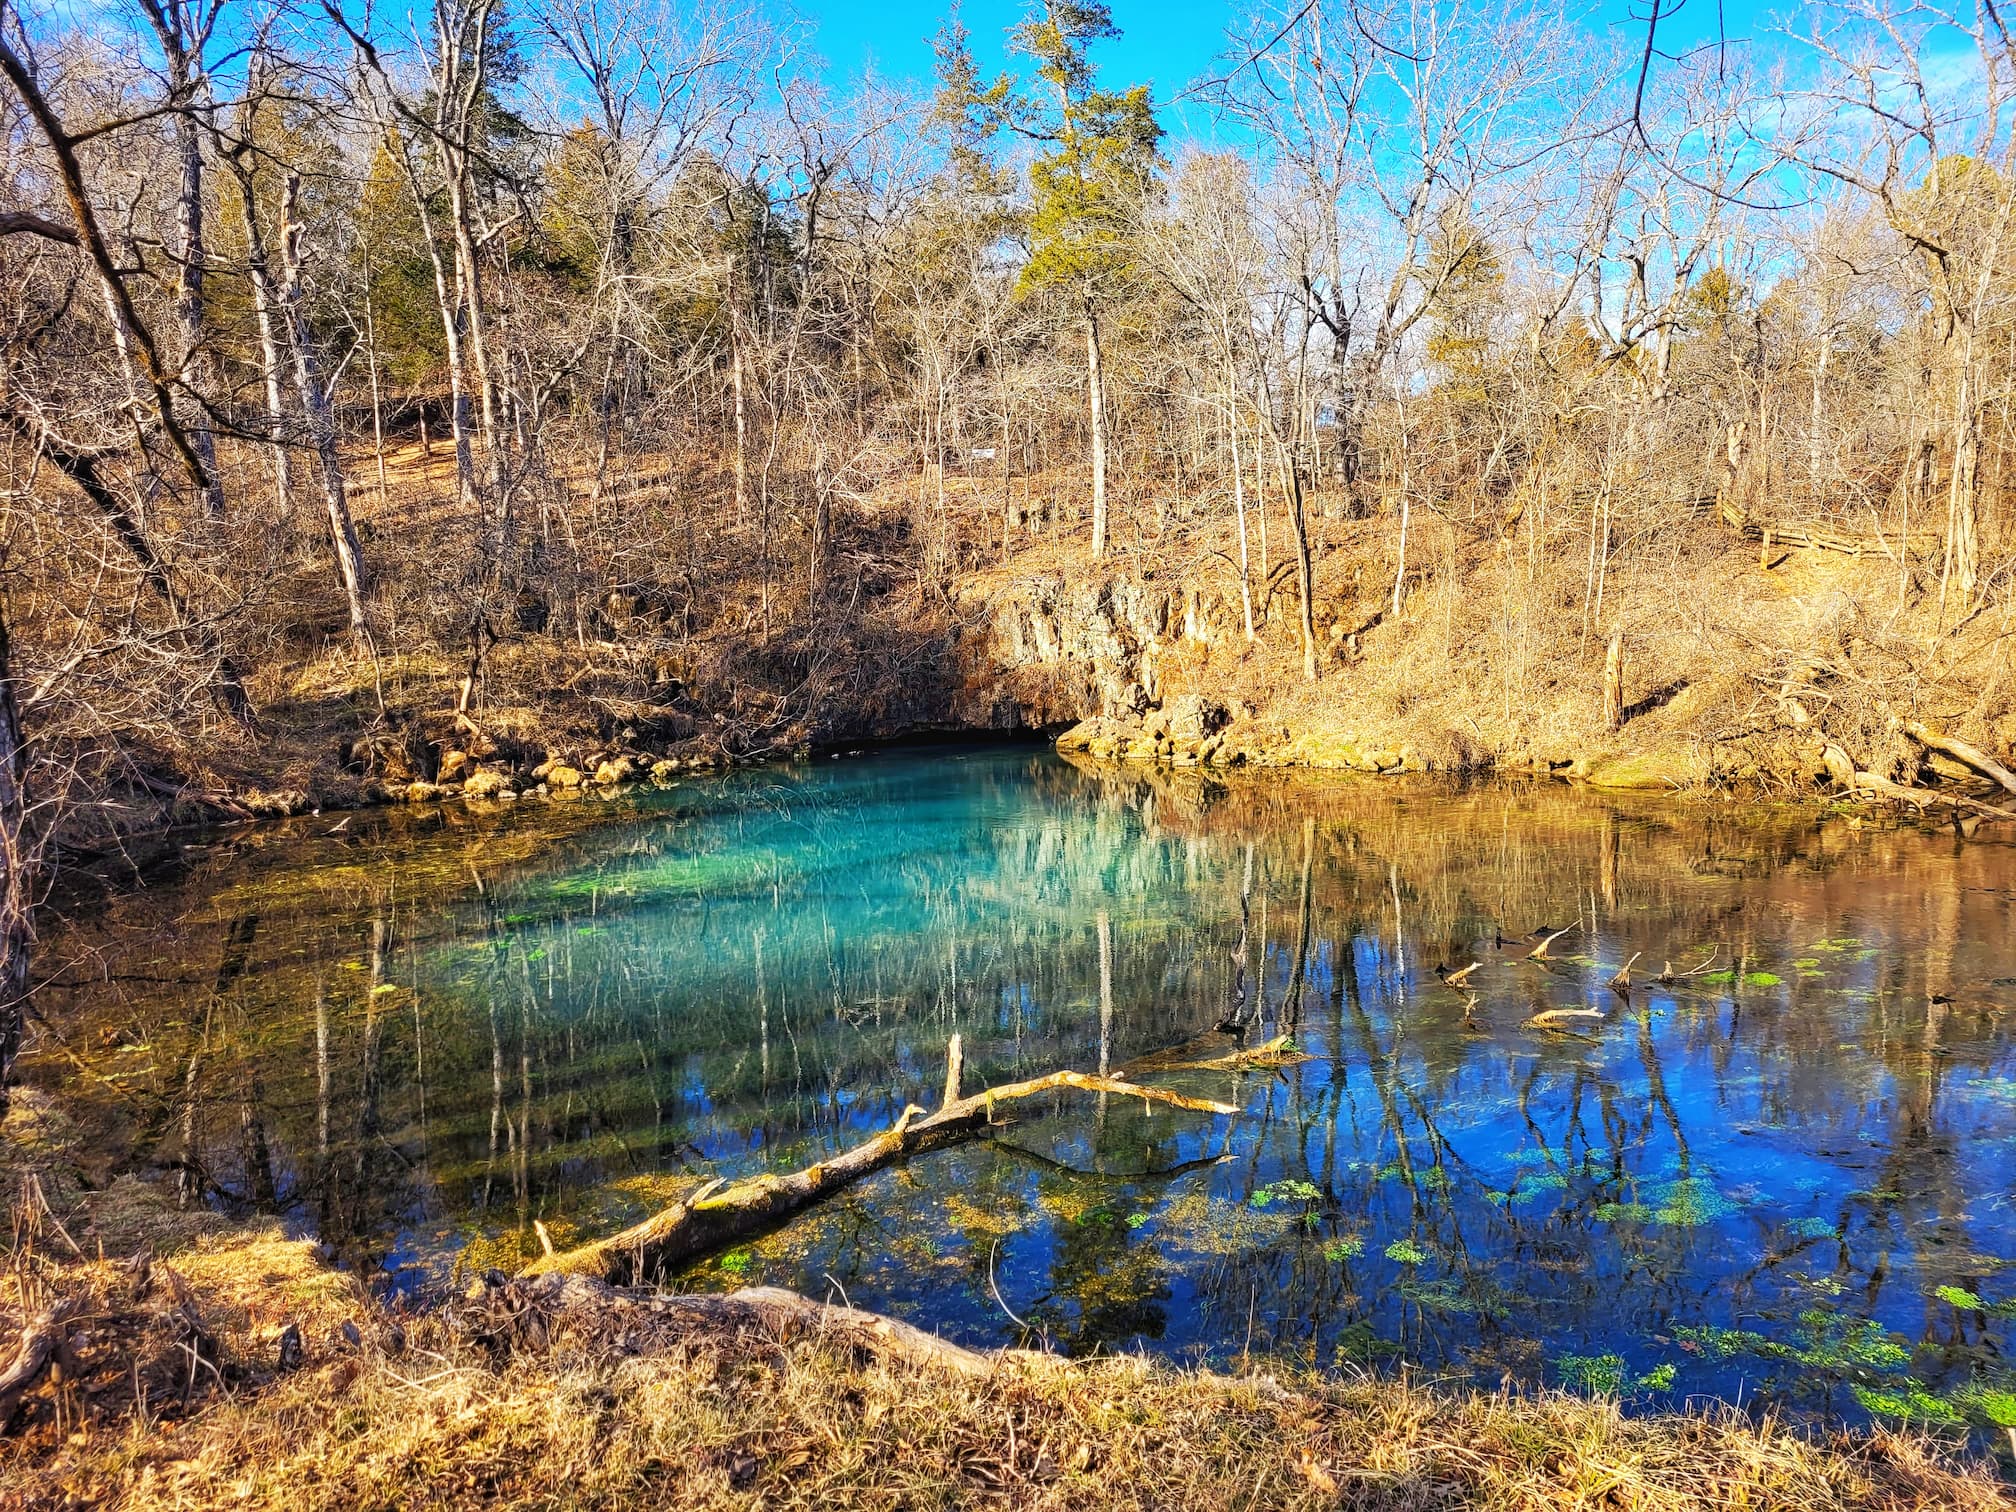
[522,1070,1238,1286]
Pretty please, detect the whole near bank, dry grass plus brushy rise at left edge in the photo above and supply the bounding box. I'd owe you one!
[0,1097,2016,1512]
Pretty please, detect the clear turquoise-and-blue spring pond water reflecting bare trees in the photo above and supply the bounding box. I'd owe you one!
[26,748,2016,1456]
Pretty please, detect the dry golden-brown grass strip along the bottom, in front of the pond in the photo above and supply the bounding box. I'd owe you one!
[6,1266,2012,1512]
